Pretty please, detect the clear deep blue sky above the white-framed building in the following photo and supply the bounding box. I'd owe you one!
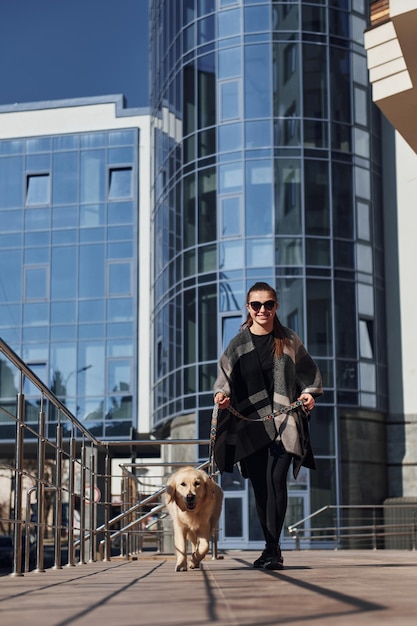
[0,0,149,107]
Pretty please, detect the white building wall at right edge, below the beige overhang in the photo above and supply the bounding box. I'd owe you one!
[383,122,417,497]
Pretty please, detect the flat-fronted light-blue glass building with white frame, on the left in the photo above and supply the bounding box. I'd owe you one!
[0,97,149,439]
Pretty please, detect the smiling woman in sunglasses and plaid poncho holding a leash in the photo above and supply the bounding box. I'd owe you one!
[214,282,323,569]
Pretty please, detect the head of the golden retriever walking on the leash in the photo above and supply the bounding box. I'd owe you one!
[166,466,210,512]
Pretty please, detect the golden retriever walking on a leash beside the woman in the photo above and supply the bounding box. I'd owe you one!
[165,466,223,572]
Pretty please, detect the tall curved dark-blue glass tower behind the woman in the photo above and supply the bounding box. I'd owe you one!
[150,0,387,546]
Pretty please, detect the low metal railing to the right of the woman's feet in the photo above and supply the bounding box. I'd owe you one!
[288,502,417,550]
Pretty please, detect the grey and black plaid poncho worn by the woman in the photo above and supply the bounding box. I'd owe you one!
[214,327,323,476]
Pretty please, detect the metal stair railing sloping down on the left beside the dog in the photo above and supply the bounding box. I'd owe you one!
[0,339,214,576]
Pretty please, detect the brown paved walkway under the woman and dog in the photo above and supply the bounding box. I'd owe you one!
[0,550,417,626]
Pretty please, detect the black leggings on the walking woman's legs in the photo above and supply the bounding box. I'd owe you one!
[243,442,292,543]
